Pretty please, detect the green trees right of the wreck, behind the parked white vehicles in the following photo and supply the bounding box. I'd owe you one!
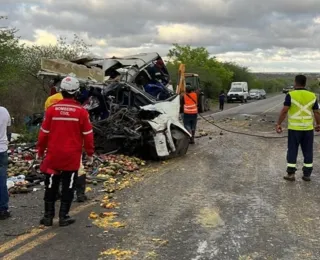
[167,44,298,99]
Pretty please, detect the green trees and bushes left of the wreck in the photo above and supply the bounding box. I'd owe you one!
[0,17,90,127]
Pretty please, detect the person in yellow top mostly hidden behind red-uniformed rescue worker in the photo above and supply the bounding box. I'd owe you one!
[44,80,88,202]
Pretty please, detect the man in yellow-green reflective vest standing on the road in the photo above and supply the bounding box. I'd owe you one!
[276,75,320,181]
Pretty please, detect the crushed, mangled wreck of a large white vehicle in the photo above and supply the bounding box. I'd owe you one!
[38,53,190,160]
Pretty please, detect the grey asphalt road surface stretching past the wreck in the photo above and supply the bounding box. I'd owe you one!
[0,95,320,260]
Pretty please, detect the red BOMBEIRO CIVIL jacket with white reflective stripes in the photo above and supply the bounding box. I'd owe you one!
[37,99,94,174]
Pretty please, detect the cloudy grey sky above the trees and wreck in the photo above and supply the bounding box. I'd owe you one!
[0,0,320,72]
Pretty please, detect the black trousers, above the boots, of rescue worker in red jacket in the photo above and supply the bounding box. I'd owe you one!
[44,171,78,204]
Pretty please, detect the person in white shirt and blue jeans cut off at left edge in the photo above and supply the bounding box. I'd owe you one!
[0,107,11,220]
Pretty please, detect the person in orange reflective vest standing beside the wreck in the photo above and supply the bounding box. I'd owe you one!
[181,85,198,144]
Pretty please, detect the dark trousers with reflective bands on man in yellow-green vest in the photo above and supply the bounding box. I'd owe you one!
[287,130,314,176]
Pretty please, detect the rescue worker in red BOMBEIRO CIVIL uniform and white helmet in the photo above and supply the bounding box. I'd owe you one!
[37,76,94,226]
